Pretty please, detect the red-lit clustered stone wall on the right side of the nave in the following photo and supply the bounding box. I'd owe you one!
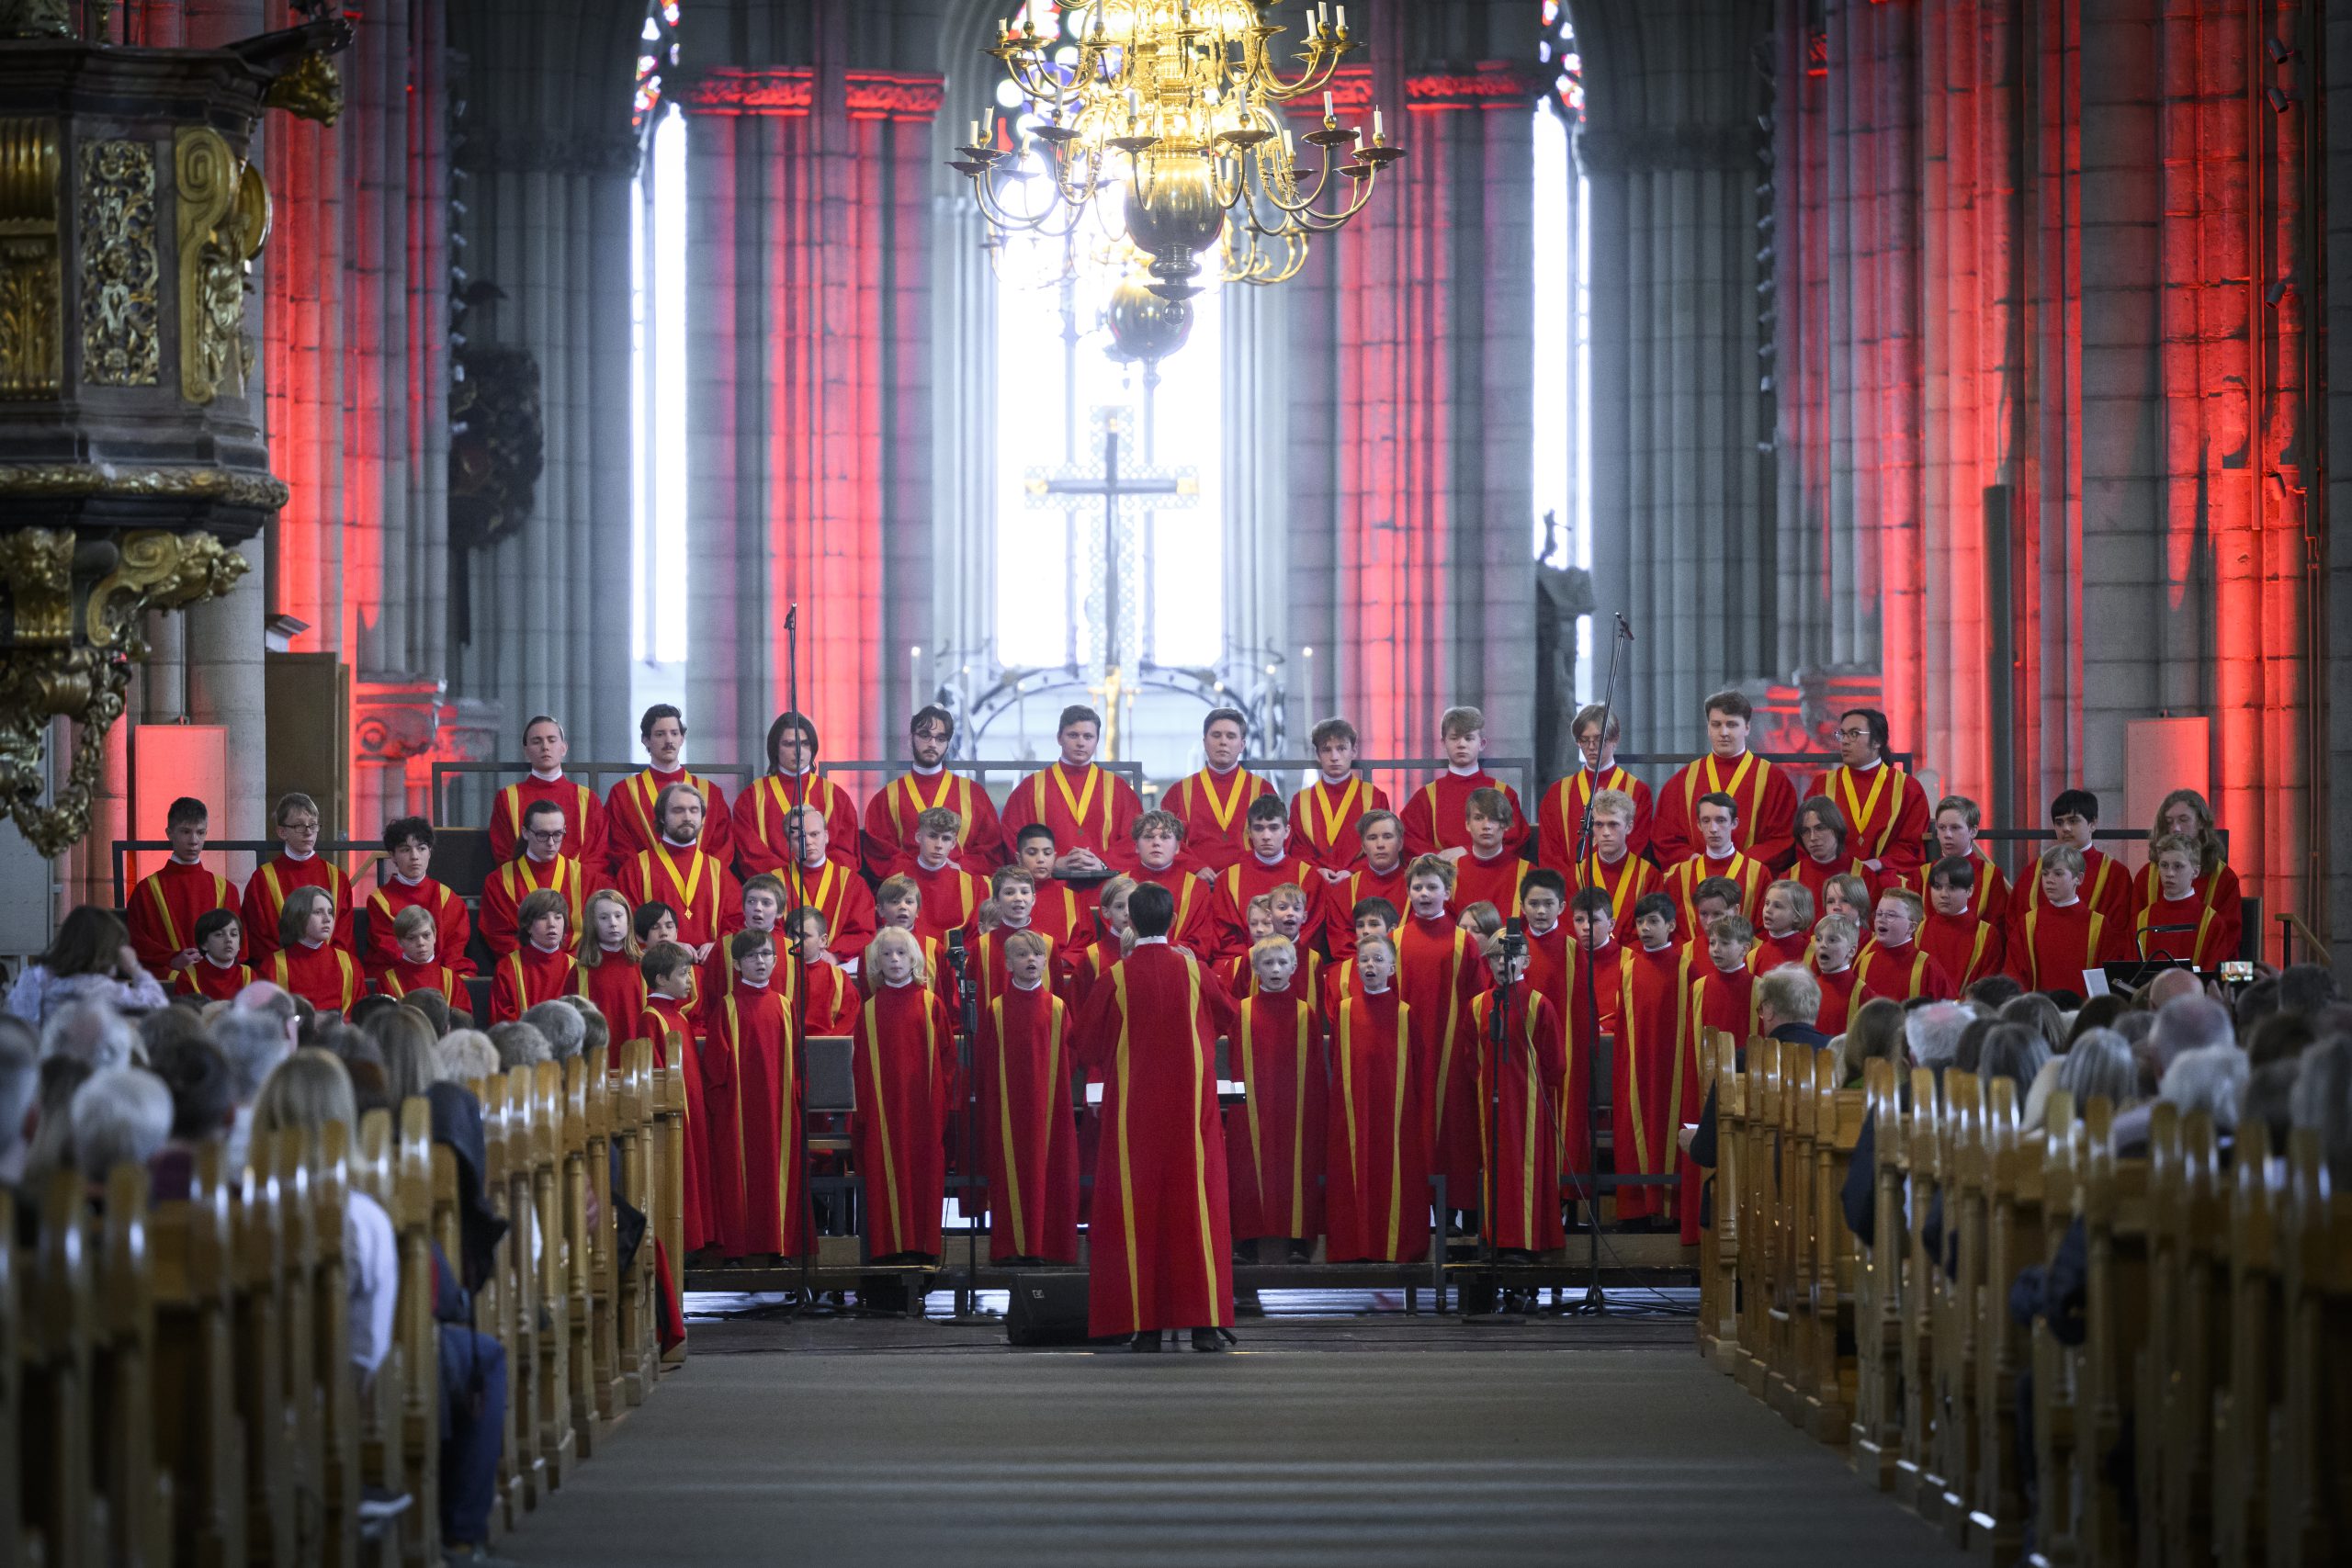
[1773,0,2324,931]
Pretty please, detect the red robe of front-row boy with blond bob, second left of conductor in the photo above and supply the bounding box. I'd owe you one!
[849,980,955,1258]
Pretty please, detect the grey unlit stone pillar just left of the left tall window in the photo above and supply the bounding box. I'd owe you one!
[449,0,644,771]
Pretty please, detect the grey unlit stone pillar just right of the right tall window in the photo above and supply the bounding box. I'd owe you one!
[1574,0,1785,752]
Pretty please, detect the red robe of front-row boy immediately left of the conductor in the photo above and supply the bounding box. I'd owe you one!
[974,985,1077,1262]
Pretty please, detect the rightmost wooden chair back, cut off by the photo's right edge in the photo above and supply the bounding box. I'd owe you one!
[2267,1128,2352,1563]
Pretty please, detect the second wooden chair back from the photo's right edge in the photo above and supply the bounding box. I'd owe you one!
[2213,1122,2289,1568]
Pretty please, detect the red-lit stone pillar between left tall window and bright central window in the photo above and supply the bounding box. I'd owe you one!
[680,61,941,761]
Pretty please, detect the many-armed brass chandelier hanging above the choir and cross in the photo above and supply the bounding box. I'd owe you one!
[950,0,1404,301]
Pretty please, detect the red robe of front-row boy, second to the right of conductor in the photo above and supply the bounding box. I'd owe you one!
[1324,987,1430,1262]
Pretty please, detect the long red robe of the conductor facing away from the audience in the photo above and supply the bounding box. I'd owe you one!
[1077,942,1238,1337]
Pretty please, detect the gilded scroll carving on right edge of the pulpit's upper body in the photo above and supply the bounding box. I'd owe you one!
[172,125,270,402]
